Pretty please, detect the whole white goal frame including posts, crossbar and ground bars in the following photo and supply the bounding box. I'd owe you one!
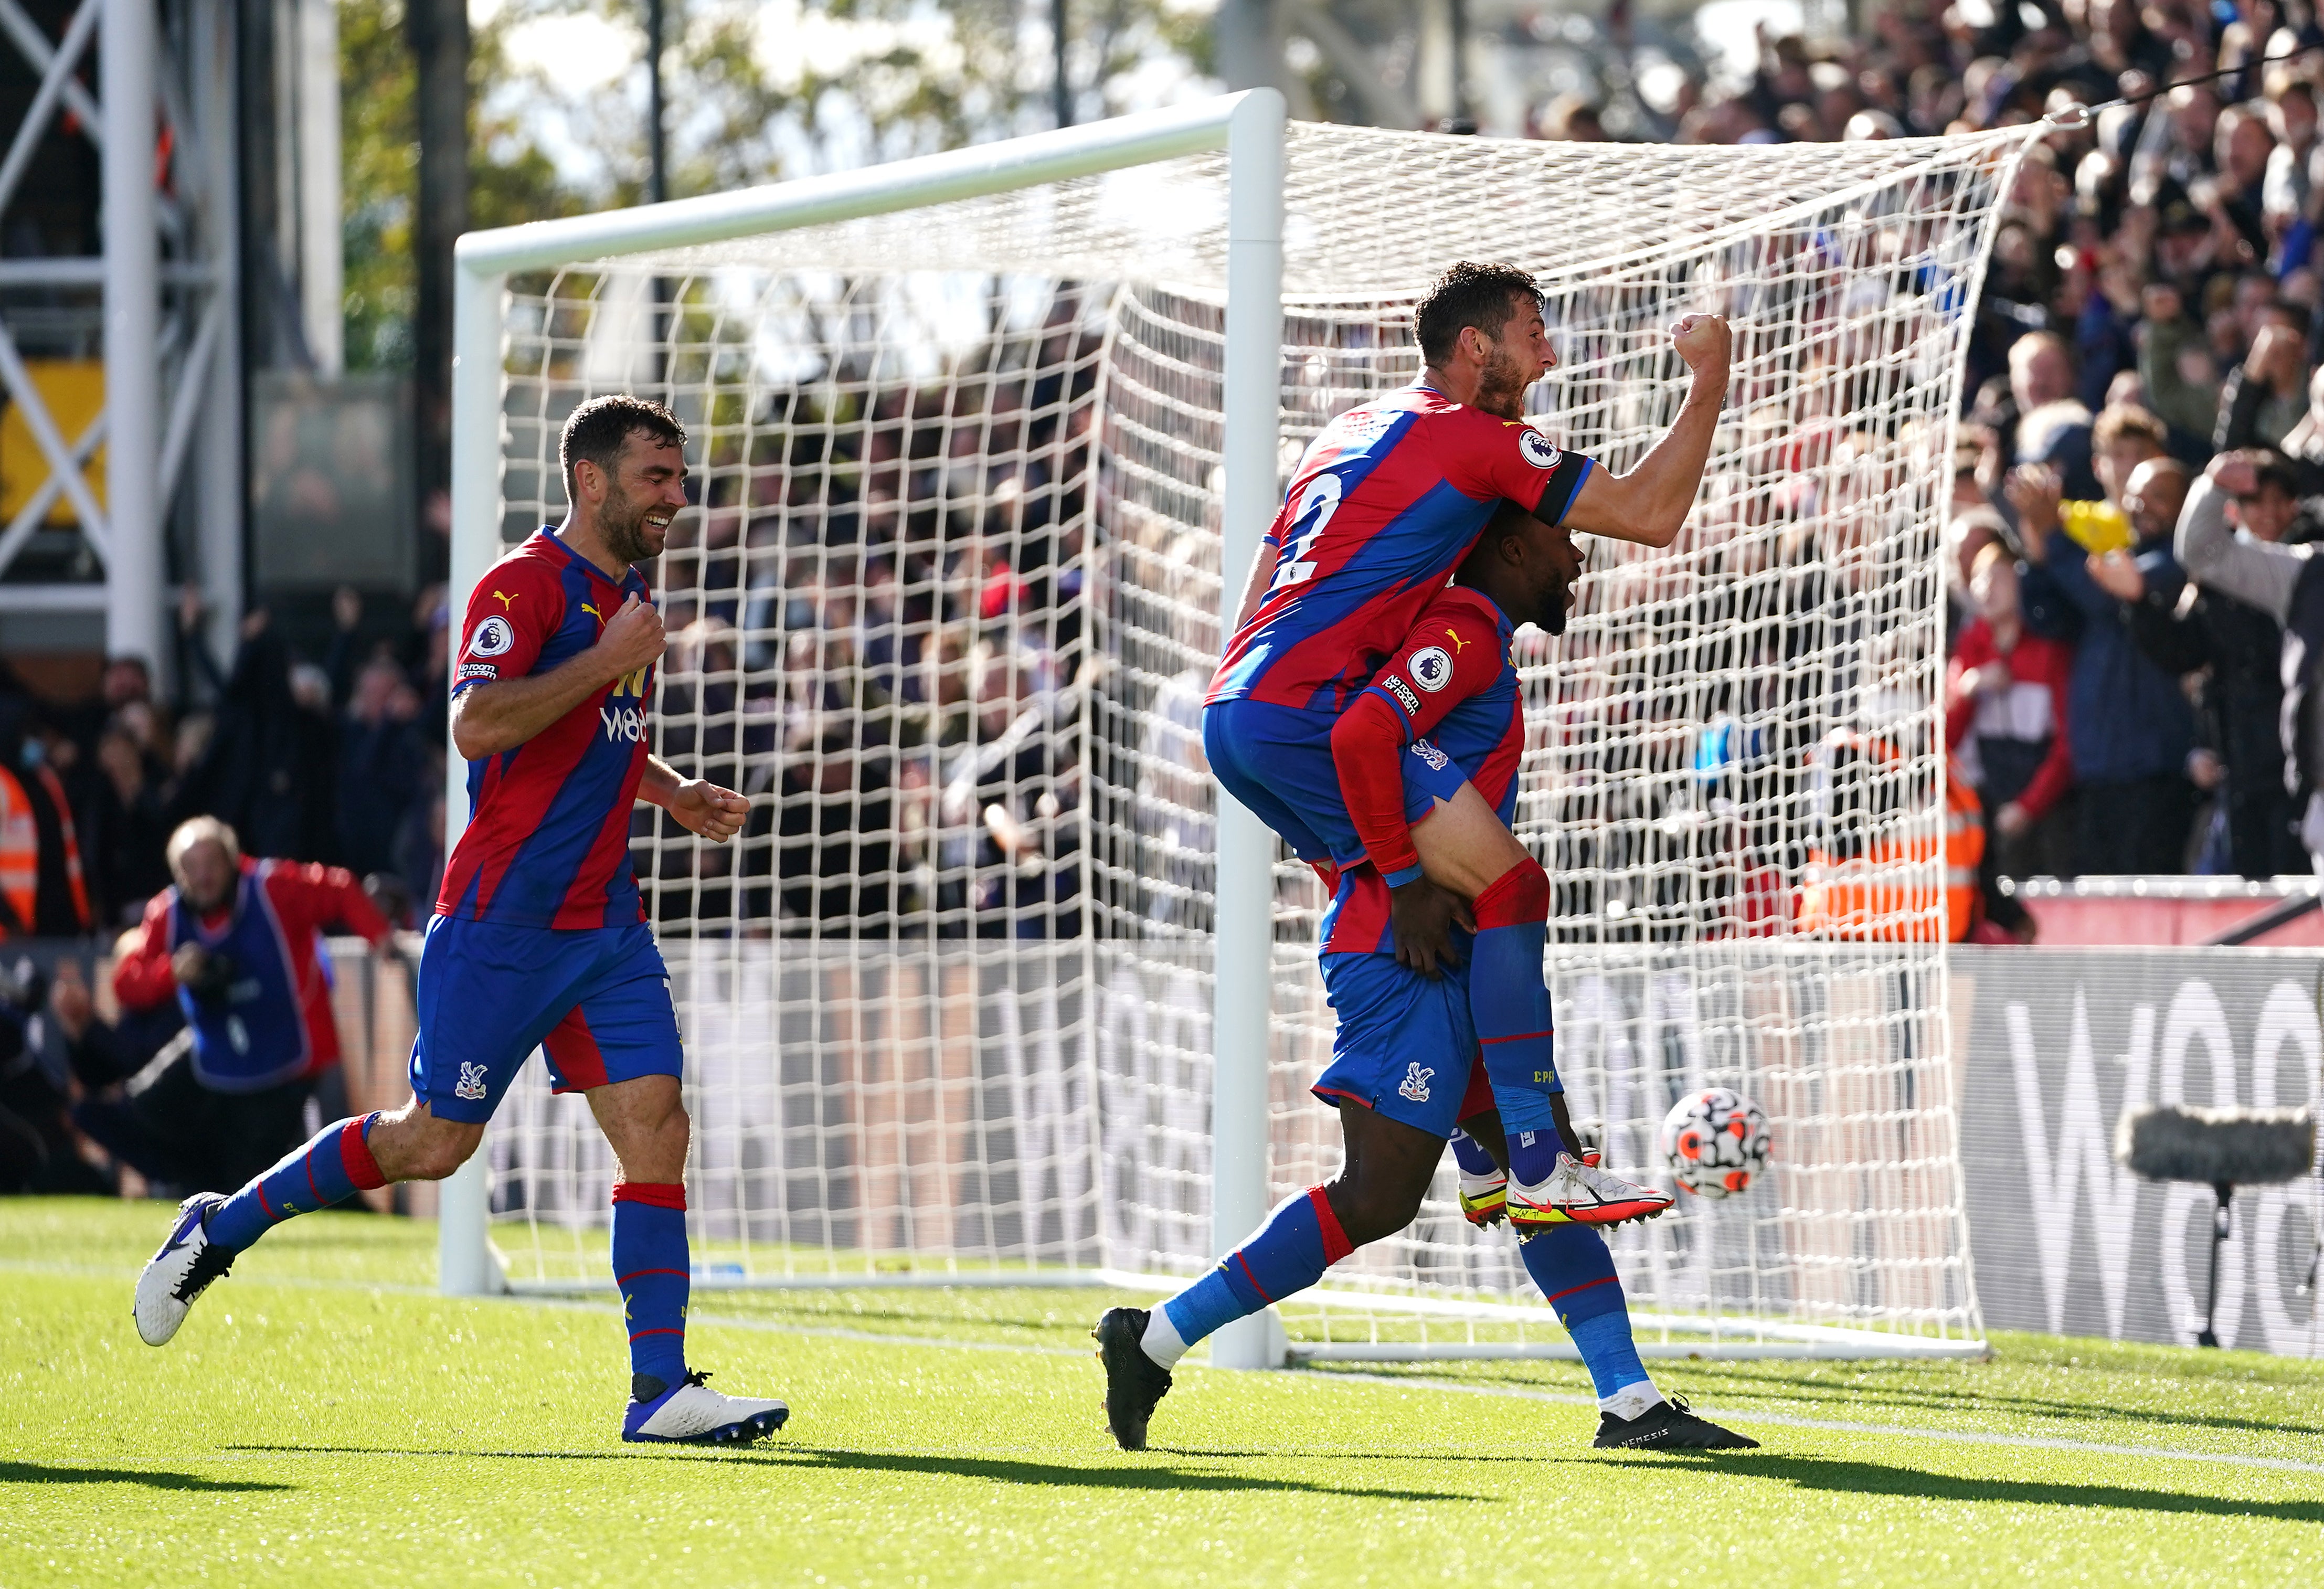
[439,99,2029,1368]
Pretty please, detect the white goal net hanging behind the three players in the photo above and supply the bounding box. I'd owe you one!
[448,99,2031,1357]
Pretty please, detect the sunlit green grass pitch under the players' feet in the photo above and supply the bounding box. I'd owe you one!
[0,1201,2324,1589]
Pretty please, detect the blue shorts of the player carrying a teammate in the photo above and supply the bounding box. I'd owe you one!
[1313,955,1492,1136]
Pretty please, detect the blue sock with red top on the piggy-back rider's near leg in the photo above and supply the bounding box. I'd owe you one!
[1469,860,1564,1185]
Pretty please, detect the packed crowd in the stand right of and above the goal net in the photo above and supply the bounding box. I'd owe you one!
[1627,0,2324,878]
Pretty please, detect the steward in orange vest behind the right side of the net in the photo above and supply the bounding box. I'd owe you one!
[1799,729,1985,943]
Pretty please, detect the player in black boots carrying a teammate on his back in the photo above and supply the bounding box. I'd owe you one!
[1095,509,1752,1449]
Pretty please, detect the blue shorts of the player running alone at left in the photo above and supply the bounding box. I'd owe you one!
[411,915,681,1122]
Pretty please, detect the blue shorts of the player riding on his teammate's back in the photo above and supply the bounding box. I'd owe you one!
[1202,699,1469,866]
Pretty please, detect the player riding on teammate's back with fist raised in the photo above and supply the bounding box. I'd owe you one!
[1204,265,1732,1224]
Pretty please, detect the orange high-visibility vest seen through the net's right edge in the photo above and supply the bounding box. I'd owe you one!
[1799,744,1985,943]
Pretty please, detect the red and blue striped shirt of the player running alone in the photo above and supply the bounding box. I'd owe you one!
[437,527,655,929]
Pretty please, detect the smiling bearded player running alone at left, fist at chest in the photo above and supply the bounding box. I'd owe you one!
[137,397,790,1440]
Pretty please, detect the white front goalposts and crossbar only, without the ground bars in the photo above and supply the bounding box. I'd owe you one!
[437,88,1288,1368]
